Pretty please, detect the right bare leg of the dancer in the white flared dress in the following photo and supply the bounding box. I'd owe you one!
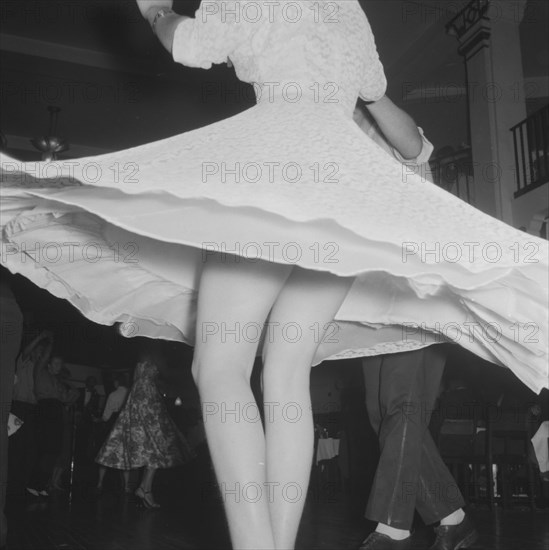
[263,268,353,550]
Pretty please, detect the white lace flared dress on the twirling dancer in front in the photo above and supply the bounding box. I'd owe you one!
[1,0,548,391]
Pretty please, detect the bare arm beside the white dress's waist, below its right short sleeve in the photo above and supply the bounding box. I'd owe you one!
[366,96,423,159]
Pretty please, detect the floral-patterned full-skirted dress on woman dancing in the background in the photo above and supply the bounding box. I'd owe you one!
[95,361,193,470]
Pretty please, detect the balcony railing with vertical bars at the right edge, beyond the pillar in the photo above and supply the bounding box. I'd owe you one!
[511,104,549,197]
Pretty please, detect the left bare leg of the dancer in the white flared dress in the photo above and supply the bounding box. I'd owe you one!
[193,255,292,550]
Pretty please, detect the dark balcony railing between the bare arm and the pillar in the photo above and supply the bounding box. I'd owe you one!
[429,147,473,203]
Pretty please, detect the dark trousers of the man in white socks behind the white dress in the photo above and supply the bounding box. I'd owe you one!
[363,345,465,530]
